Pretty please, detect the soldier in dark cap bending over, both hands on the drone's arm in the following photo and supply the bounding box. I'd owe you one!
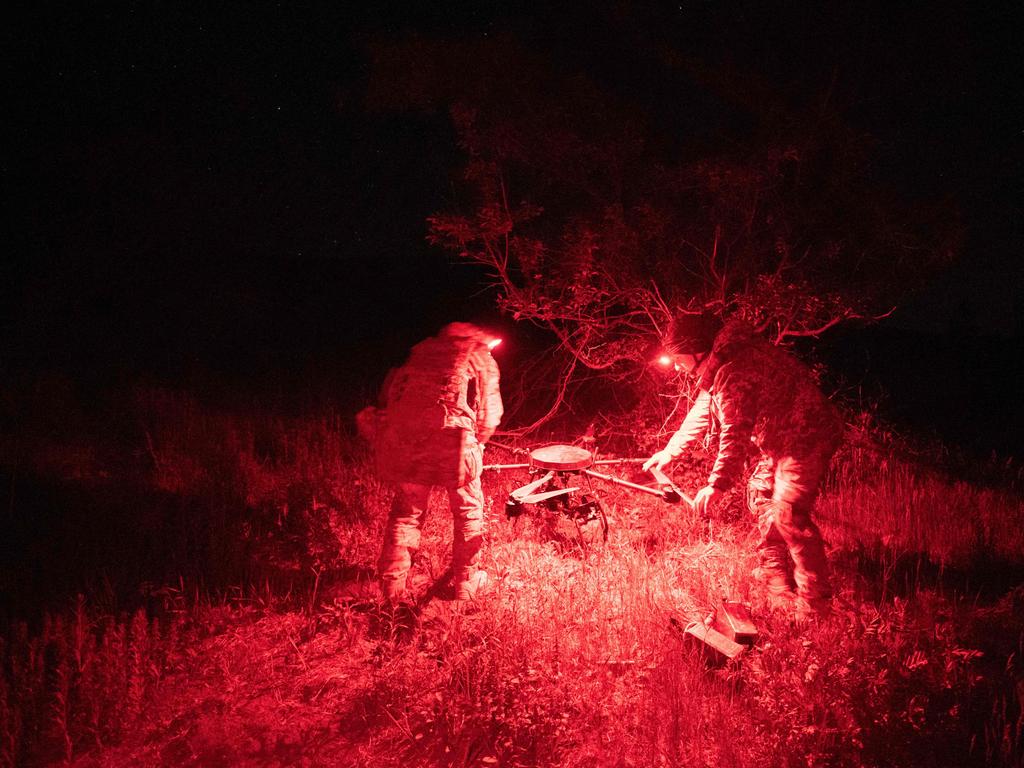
[644,316,843,612]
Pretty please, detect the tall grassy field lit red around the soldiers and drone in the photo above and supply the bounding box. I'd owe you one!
[0,391,1024,767]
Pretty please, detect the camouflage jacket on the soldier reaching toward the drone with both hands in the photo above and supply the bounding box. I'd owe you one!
[666,321,843,490]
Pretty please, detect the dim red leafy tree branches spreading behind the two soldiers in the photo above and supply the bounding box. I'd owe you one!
[374,31,956,434]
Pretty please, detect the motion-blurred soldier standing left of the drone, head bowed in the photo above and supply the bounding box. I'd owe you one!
[366,323,503,602]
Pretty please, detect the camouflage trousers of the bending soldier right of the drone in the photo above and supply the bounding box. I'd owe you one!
[746,451,831,600]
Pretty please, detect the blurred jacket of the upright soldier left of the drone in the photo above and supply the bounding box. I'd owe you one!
[375,324,503,487]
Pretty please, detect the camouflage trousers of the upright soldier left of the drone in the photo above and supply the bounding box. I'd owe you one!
[377,477,484,601]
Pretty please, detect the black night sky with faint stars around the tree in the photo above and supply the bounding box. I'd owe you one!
[0,0,1024,450]
